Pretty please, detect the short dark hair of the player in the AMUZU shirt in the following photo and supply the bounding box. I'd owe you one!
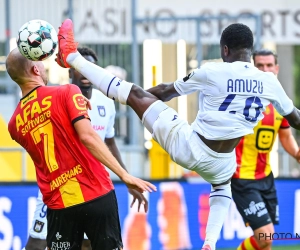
[220,23,253,50]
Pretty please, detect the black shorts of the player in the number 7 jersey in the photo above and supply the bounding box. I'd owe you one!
[47,190,123,250]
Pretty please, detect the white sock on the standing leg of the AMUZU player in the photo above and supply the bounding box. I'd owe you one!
[203,183,231,250]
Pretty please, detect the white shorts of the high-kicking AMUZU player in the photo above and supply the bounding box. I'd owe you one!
[150,108,236,184]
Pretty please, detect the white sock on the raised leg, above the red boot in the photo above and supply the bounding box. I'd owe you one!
[67,52,133,104]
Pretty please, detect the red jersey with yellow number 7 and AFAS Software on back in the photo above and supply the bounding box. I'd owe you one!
[8,84,113,209]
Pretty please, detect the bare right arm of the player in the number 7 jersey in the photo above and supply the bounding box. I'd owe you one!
[74,119,156,192]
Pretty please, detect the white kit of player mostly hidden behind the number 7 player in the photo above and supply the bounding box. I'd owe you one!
[29,89,116,240]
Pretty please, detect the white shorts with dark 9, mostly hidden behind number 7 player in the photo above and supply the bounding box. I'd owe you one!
[29,190,88,240]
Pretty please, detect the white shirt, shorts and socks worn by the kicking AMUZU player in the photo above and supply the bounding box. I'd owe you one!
[68,53,294,250]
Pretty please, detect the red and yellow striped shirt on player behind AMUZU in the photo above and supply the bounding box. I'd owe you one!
[233,104,290,180]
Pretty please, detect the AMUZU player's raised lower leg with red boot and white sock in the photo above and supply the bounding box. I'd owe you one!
[56,19,168,126]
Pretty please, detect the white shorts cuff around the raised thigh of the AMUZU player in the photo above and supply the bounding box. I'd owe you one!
[142,100,169,133]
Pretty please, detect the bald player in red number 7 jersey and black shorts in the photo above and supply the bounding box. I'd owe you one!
[6,49,155,250]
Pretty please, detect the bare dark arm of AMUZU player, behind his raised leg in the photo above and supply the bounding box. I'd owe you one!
[147,83,179,102]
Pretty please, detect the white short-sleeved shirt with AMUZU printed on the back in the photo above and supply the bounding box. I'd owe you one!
[174,61,294,140]
